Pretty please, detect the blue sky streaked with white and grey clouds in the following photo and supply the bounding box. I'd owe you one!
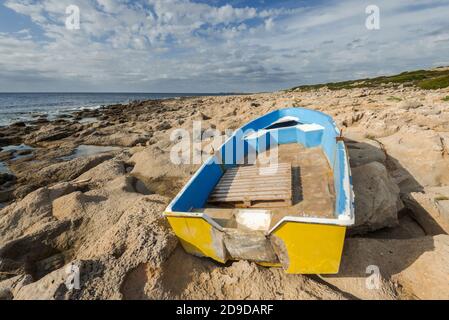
[0,0,449,92]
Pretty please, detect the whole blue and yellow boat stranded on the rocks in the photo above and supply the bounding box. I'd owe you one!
[165,108,354,274]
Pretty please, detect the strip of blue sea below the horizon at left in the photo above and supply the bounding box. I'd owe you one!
[0,93,227,126]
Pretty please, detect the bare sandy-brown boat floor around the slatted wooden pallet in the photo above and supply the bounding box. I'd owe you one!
[201,144,335,227]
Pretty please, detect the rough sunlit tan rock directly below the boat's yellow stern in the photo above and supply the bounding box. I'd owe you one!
[126,248,346,300]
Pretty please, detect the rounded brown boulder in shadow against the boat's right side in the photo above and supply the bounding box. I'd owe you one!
[345,139,445,238]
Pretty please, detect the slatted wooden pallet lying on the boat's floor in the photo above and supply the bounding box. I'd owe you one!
[209,163,292,208]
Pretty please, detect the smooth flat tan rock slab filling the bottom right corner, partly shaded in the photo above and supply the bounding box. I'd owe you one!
[323,235,449,299]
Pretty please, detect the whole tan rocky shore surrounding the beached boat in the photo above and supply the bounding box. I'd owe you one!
[0,86,449,299]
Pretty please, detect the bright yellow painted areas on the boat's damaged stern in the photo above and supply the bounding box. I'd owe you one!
[166,213,346,274]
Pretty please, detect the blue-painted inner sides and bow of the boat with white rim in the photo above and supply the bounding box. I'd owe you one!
[168,108,352,225]
